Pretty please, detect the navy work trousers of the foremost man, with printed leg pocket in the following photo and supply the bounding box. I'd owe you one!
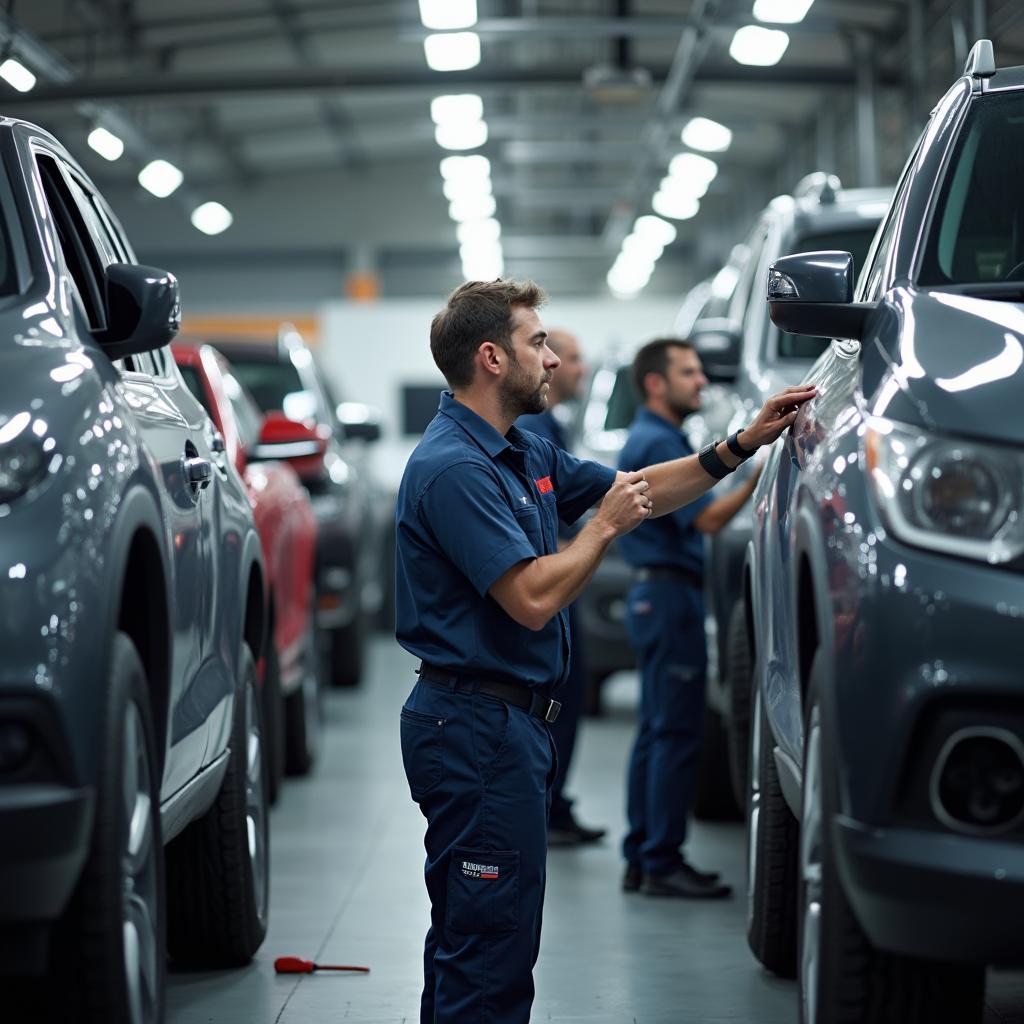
[401,682,554,1024]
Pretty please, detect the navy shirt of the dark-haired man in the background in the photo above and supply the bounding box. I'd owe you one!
[618,407,713,575]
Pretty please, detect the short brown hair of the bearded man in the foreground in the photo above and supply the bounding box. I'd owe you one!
[430,278,547,388]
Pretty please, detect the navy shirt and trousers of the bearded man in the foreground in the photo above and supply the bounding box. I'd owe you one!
[395,392,614,1024]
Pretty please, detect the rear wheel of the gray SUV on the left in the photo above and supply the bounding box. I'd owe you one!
[167,646,269,968]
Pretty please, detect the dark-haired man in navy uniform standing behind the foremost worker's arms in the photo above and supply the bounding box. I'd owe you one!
[618,338,760,899]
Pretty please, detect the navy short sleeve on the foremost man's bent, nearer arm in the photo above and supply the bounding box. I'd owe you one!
[418,461,537,597]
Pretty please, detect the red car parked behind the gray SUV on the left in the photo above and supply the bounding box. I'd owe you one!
[171,342,321,797]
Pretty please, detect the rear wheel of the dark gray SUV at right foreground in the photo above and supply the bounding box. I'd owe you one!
[746,682,800,978]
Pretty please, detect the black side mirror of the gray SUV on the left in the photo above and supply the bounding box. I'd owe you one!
[98,263,181,359]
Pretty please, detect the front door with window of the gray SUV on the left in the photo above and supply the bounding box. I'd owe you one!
[35,146,208,799]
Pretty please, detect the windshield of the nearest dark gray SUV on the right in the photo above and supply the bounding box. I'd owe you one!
[918,92,1024,286]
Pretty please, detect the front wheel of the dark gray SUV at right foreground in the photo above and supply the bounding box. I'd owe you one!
[798,651,985,1024]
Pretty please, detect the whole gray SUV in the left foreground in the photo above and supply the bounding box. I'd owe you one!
[0,120,268,1024]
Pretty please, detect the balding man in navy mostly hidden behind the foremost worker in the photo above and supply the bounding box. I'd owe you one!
[516,329,607,846]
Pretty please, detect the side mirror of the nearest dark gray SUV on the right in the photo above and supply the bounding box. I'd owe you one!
[768,250,874,341]
